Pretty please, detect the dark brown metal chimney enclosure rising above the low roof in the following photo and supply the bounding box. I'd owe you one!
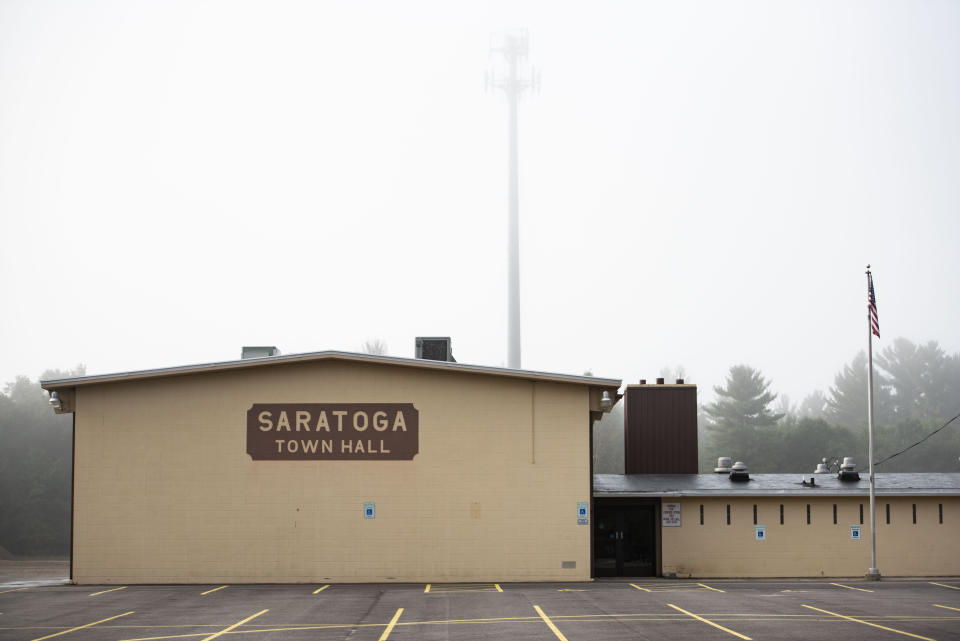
[623,379,697,474]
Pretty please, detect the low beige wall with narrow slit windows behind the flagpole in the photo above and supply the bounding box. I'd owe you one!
[662,497,960,577]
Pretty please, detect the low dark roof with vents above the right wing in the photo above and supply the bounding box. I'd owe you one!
[593,472,960,498]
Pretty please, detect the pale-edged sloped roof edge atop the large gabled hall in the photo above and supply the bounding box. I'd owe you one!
[40,350,621,394]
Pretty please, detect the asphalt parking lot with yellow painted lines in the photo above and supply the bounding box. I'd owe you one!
[0,578,960,641]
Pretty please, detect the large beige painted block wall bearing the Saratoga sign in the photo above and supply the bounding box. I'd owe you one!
[74,361,590,583]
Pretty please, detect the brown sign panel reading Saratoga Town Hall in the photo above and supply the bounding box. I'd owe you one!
[247,403,420,461]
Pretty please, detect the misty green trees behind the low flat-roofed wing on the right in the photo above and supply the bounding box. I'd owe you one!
[594,338,960,474]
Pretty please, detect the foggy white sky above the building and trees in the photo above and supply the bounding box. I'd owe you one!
[0,0,960,402]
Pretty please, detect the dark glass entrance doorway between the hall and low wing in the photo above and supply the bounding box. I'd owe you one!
[593,502,660,577]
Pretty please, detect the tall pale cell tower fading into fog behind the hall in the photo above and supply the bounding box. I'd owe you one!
[487,31,539,369]
